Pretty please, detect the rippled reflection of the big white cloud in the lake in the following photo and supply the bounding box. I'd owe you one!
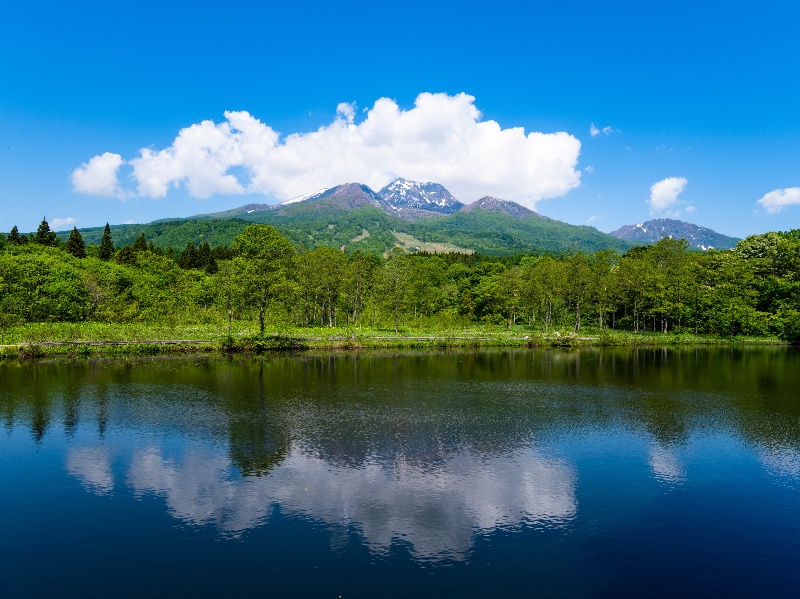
[67,445,577,559]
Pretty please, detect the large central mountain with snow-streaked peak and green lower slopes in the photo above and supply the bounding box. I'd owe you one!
[60,179,633,255]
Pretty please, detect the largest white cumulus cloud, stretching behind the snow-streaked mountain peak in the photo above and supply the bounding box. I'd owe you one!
[73,93,581,207]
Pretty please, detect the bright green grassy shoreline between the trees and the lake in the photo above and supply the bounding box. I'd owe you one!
[0,323,789,360]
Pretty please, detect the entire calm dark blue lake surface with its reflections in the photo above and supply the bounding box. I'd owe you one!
[0,348,800,599]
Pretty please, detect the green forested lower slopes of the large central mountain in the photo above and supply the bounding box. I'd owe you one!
[61,200,632,255]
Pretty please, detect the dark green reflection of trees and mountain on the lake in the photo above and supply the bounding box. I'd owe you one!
[0,347,800,468]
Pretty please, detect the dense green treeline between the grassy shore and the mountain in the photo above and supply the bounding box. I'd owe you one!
[0,221,800,339]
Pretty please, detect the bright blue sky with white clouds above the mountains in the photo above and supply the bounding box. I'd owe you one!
[0,0,800,237]
